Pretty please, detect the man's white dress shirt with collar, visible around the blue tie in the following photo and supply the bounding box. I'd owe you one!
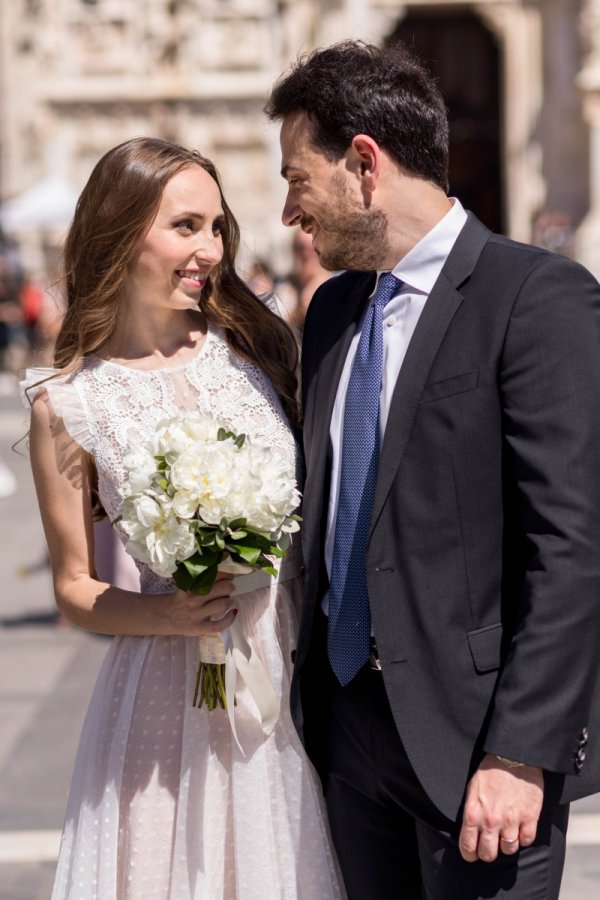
[323,198,467,613]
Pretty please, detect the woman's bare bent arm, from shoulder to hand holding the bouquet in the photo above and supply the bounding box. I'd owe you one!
[30,392,235,635]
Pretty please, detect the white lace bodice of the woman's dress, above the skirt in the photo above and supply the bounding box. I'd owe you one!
[22,325,298,592]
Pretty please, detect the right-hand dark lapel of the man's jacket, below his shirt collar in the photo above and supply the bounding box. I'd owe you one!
[371,214,490,530]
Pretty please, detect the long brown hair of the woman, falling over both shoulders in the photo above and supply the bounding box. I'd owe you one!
[54,137,299,424]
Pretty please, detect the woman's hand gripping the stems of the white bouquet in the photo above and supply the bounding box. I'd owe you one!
[168,572,237,637]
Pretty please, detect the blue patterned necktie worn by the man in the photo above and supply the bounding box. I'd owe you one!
[327,272,401,685]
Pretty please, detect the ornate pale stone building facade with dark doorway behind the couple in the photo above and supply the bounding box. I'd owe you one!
[0,0,600,275]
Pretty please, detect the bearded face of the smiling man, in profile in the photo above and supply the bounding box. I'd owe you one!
[281,113,388,272]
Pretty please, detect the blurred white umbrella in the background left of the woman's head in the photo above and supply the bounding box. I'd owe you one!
[0,175,77,231]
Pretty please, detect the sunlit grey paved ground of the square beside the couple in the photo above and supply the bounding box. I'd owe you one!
[0,375,600,900]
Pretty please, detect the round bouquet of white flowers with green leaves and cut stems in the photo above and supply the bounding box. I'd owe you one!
[117,413,300,710]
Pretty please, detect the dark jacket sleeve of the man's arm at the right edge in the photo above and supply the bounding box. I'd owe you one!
[485,256,600,774]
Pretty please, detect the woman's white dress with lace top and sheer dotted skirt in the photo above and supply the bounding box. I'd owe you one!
[25,328,343,900]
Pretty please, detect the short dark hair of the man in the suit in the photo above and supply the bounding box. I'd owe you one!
[265,41,448,191]
